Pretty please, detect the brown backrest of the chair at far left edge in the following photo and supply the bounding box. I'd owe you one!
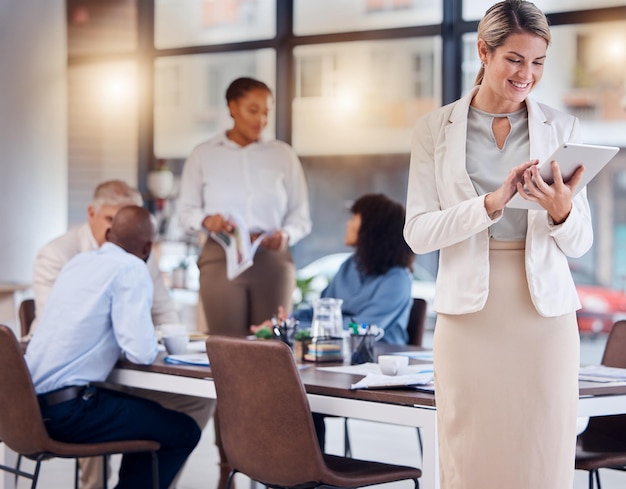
[0,324,50,455]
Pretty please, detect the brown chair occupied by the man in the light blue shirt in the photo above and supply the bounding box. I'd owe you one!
[0,325,160,489]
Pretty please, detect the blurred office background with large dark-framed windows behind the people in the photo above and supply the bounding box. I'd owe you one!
[0,0,626,336]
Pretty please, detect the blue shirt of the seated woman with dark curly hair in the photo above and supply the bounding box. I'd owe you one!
[295,255,412,345]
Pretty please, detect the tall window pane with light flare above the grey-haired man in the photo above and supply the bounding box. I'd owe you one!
[68,61,138,225]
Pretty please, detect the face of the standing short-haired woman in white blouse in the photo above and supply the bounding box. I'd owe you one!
[227,88,272,146]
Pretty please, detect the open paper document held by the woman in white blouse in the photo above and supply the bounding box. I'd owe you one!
[211,214,268,280]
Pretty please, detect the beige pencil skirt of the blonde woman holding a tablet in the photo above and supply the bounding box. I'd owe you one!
[434,241,580,489]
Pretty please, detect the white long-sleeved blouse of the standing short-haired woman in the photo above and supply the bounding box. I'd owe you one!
[179,133,311,245]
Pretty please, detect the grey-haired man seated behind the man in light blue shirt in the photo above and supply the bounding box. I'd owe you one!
[31,180,215,489]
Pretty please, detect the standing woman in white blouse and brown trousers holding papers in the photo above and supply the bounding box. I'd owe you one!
[179,78,311,336]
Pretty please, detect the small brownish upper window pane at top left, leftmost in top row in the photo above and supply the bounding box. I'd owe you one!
[66,0,137,56]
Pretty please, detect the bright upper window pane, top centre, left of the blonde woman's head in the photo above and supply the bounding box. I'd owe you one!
[294,0,442,36]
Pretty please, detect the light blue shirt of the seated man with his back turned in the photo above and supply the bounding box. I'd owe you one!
[26,243,158,394]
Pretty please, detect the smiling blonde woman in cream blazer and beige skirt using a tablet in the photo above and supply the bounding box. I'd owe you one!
[404,0,593,489]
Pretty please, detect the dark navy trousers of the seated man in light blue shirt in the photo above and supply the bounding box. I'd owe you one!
[41,387,201,489]
